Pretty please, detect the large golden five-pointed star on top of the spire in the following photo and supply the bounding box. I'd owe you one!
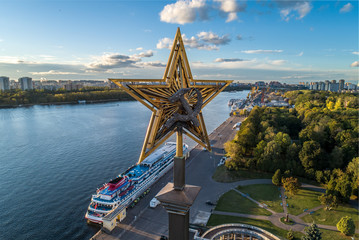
[109,28,232,163]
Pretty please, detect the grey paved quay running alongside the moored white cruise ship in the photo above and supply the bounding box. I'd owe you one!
[91,117,244,240]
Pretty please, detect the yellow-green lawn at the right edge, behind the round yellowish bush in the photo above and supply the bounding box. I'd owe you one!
[302,205,359,229]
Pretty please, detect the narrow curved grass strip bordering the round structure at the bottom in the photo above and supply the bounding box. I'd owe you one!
[207,214,304,239]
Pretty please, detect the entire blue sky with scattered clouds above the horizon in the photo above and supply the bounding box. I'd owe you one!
[0,0,359,83]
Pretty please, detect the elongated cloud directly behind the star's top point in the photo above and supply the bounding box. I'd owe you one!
[156,32,231,51]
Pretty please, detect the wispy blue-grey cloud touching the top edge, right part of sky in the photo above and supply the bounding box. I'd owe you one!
[276,0,313,21]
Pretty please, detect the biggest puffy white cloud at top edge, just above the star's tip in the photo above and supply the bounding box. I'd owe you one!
[160,0,206,24]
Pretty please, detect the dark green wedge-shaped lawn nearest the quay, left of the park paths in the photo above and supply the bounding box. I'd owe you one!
[215,190,271,216]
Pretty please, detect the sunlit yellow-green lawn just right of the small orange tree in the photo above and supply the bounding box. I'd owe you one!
[287,189,322,215]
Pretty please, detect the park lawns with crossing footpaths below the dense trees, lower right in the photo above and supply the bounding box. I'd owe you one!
[207,184,359,240]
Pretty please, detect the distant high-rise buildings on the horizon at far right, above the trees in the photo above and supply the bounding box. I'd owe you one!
[299,79,359,92]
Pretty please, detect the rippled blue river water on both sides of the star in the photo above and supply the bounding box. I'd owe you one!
[0,91,248,240]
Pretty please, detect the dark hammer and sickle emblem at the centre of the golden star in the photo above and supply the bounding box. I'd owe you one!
[165,88,203,128]
